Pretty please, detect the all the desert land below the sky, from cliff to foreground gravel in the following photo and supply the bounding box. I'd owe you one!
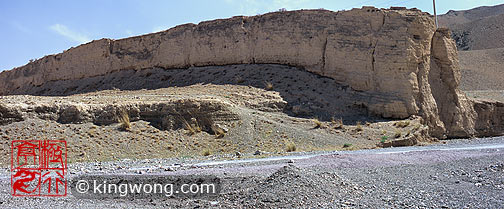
[0,5,504,208]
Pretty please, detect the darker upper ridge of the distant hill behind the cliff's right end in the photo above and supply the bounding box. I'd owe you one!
[439,4,504,50]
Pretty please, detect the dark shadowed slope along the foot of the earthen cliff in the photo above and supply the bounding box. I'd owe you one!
[12,64,390,124]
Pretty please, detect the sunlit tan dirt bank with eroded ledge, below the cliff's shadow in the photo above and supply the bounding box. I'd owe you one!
[0,83,429,166]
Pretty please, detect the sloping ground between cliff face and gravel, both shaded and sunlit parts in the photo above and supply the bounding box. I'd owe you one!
[0,65,435,166]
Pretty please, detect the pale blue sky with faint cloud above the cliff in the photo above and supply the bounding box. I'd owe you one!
[0,0,503,71]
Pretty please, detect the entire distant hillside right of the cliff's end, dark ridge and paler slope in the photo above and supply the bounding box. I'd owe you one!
[439,5,504,114]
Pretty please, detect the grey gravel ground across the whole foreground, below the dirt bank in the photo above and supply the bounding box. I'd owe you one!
[0,137,504,208]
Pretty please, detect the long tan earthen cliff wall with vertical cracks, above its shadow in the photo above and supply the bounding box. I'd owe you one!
[0,7,502,137]
